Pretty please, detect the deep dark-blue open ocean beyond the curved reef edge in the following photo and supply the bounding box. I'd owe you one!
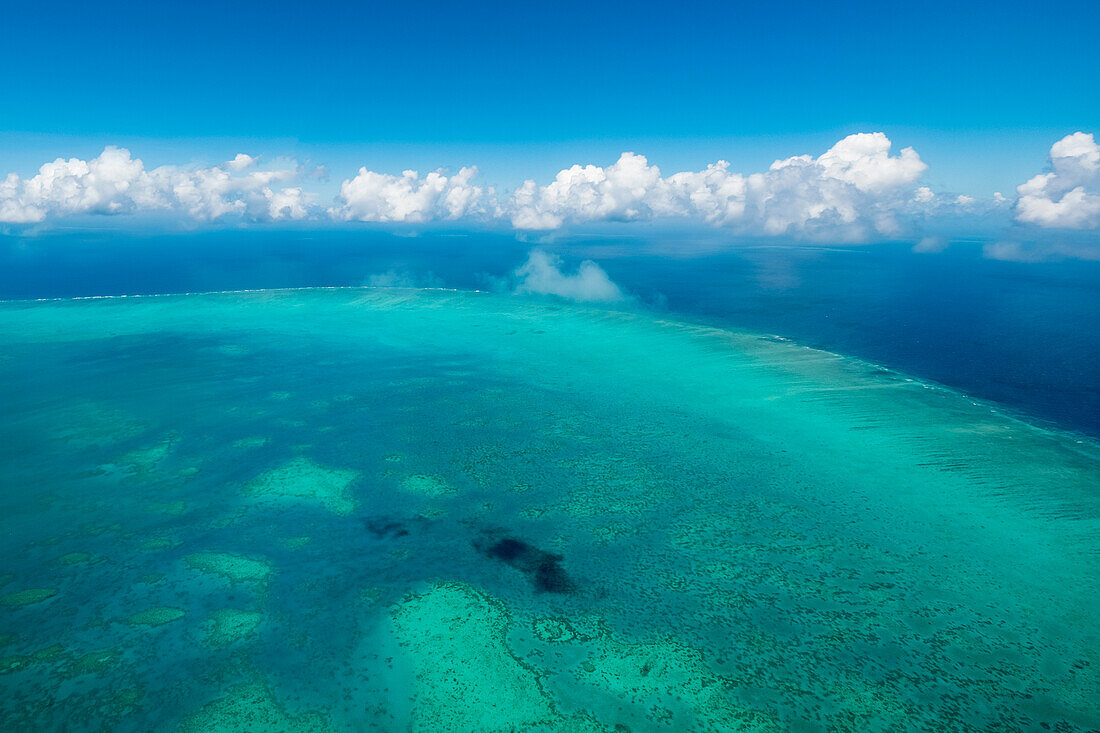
[0,229,1100,436]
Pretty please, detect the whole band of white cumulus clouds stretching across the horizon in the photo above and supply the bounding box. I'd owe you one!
[0,132,1100,252]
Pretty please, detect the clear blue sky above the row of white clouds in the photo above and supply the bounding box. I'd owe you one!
[0,1,1100,248]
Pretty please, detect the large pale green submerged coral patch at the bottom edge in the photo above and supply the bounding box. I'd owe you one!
[393,583,783,732]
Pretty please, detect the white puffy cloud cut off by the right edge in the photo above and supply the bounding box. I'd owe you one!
[1016,132,1100,229]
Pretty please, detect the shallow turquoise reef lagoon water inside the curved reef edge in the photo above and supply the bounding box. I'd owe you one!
[0,288,1100,731]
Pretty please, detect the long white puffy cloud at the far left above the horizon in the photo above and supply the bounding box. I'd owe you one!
[0,146,312,223]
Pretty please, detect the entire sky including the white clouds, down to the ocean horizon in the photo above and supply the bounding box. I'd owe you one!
[0,0,1100,259]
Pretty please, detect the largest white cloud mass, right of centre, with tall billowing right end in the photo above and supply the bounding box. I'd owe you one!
[508,132,931,240]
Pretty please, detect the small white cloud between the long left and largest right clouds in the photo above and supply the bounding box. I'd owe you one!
[329,167,493,223]
